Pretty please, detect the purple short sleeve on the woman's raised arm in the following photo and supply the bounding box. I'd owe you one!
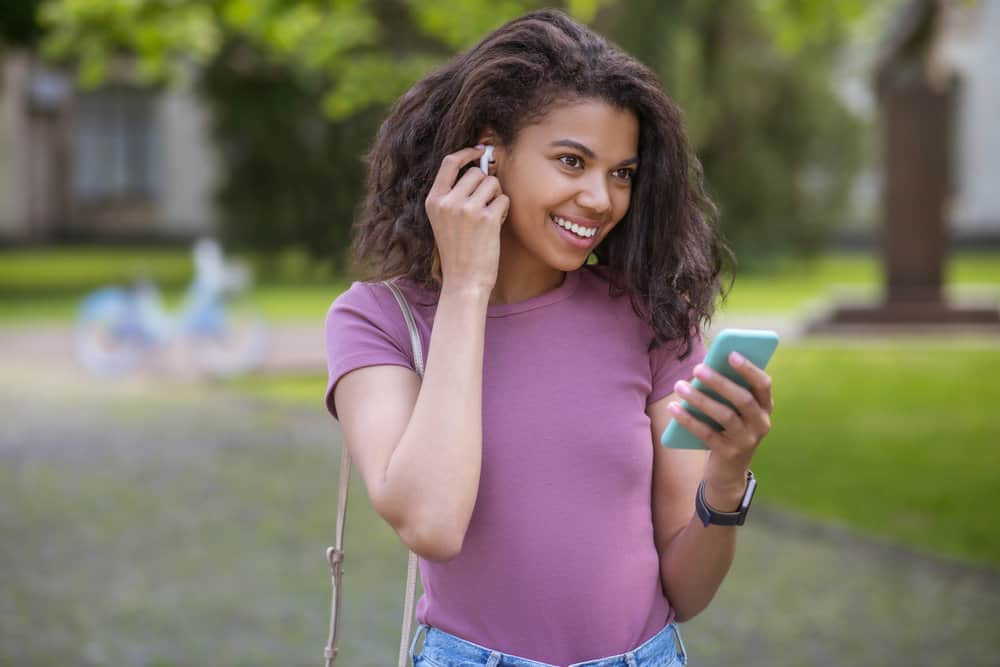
[324,282,413,419]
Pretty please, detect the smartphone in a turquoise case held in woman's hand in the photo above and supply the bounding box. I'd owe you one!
[660,329,778,449]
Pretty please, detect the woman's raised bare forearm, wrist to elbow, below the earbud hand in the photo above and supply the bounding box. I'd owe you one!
[382,288,489,558]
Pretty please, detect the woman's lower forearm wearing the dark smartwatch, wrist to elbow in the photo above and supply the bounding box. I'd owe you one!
[660,474,745,621]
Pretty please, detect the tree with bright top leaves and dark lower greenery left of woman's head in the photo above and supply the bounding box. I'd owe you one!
[40,0,607,269]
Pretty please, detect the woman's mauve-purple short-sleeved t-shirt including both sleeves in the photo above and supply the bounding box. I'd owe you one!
[326,267,705,665]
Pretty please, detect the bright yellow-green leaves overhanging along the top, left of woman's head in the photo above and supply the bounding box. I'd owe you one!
[40,0,609,120]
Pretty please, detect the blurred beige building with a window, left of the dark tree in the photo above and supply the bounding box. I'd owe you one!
[0,52,218,242]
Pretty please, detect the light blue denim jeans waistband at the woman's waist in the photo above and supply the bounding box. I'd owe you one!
[410,623,687,667]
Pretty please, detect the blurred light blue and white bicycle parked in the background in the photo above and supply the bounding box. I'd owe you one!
[74,239,270,377]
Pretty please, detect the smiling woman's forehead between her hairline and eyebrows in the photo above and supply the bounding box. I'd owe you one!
[517,100,639,163]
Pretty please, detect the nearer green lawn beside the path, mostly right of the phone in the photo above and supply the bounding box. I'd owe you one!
[231,340,1000,566]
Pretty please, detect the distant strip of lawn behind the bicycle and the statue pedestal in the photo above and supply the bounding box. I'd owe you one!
[0,247,1000,323]
